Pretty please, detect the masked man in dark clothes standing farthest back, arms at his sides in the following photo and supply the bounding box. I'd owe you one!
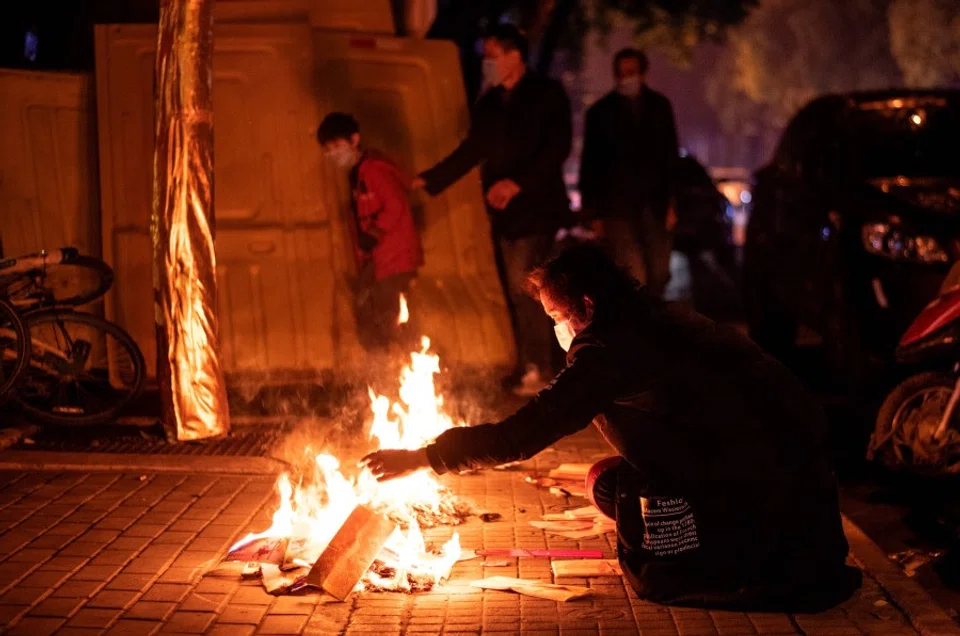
[580,49,679,296]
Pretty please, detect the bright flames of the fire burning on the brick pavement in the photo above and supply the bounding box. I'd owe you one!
[230,330,467,591]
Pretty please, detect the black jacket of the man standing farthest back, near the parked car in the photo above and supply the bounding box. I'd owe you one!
[580,86,679,217]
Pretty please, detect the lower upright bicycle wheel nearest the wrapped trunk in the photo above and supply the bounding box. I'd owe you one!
[16,309,144,425]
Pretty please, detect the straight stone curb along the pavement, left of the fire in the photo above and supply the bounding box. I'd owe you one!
[0,450,286,475]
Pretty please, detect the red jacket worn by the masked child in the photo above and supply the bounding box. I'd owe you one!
[350,151,423,280]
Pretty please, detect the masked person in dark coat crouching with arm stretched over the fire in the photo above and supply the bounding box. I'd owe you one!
[362,245,860,612]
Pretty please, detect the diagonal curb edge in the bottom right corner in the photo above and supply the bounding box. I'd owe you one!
[843,516,960,636]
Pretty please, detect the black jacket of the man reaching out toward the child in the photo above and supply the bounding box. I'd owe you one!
[420,72,572,238]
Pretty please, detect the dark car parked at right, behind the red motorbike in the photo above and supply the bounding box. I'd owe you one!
[744,90,960,388]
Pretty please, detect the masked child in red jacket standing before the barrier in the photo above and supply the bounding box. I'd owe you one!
[317,113,423,349]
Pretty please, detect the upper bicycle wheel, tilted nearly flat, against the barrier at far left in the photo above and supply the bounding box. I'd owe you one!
[2,256,113,308]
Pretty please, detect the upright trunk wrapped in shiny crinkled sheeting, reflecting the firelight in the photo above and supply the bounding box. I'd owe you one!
[150,0,230,441]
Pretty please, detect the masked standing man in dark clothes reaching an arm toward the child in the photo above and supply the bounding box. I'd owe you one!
[414,24,572,395]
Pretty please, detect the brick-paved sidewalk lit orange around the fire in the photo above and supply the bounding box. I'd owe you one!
[0,429,960,636]
